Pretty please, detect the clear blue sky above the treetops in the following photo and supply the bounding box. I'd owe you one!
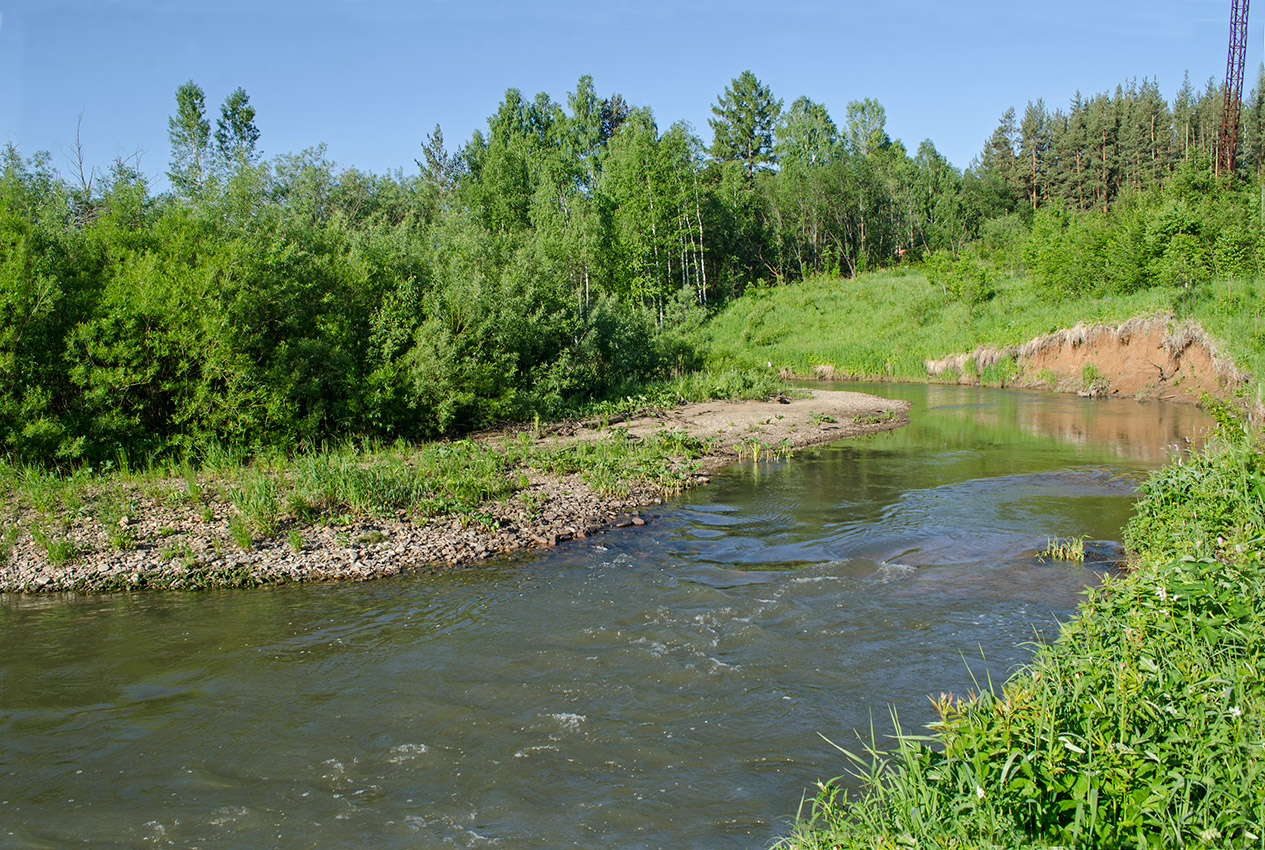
[0,0,1265,185]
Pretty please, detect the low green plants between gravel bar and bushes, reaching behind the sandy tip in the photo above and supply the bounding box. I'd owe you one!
[0,371,782,576]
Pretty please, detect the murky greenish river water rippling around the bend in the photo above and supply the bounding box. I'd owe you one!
[0,385,1207,850]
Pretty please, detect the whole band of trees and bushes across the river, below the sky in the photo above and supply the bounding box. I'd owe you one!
[0,65,1265,464]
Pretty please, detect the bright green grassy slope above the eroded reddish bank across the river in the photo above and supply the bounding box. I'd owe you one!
[698,269,1265,395]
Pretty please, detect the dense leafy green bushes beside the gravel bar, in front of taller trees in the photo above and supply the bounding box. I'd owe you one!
[0,142,694,464]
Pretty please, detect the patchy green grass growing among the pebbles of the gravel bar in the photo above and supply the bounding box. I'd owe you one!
[0,419,728,571]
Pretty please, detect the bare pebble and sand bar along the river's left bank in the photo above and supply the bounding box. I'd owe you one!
[0,390,908,593]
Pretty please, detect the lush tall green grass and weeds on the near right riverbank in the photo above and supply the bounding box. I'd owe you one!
[784,426,1265,847]
